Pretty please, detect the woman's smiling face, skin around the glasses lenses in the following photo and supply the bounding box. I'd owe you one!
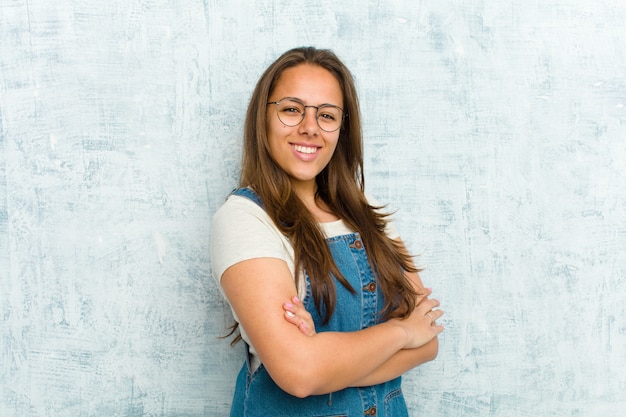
[267,64,343,194]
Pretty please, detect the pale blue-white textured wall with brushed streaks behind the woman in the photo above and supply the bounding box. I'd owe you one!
[0,0,626,417]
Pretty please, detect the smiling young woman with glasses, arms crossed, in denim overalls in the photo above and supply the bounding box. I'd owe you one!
[211,48,443,417]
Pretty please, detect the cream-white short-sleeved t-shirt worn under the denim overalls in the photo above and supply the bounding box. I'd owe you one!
[210,195,399,369]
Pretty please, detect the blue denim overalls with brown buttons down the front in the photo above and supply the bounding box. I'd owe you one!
[230,188,408,417]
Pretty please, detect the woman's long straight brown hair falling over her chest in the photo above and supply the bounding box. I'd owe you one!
[239,47,417,328]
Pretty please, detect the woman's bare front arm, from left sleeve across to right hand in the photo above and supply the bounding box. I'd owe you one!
[221,244,443,397]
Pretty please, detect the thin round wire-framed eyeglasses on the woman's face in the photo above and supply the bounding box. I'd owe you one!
[267,97,344,132]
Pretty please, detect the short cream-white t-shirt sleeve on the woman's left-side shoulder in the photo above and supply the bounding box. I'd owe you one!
[210,196,287,284]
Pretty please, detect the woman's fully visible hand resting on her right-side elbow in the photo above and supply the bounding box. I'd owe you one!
[389,289,443,349]
